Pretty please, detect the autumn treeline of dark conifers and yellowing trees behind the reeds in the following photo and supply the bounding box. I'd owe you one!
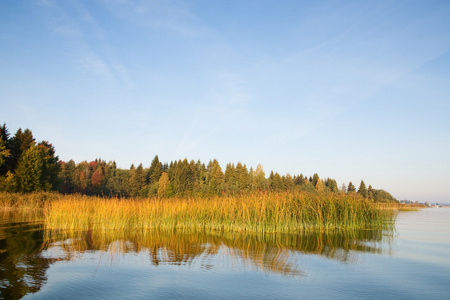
[0,124,397,202]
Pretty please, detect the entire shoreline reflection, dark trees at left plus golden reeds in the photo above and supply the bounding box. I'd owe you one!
[0,215,392,299]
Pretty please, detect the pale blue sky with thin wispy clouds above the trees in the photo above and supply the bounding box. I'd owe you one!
[0,0,450,203]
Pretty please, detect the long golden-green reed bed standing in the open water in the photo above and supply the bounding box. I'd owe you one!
[44,192,393,235]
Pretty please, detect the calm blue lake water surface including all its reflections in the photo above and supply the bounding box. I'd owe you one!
[0,208,450,299]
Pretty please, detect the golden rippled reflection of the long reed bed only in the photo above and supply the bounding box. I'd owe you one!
[44,230,392,276]
